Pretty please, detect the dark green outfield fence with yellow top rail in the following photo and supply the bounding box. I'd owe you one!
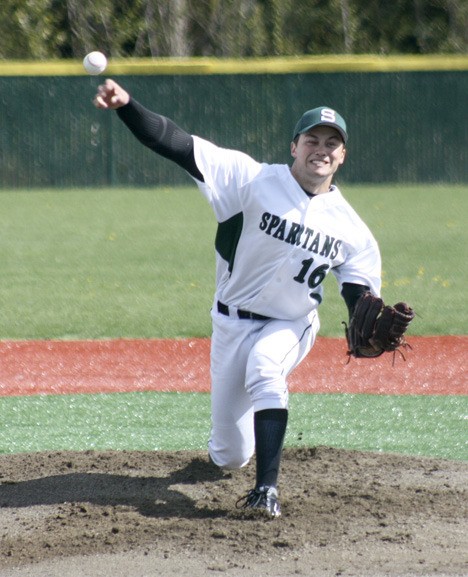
[0,56,468,188]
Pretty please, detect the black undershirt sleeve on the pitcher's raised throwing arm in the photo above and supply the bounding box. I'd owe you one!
[117,98,204,182]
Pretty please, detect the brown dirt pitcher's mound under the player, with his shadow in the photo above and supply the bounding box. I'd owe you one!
[0,447,468,577]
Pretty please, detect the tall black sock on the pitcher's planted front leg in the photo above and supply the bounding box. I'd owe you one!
[254,409,288,487]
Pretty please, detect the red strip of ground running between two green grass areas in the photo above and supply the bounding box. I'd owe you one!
[0,336,468,396]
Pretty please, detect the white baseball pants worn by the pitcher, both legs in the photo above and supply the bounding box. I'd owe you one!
[208,309,320,468]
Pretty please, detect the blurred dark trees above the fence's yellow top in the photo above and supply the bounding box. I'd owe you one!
[0,0,468,60]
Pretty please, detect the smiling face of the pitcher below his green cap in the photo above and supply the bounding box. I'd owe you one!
[291,126,346,189]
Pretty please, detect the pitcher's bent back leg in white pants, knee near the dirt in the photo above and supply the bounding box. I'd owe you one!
[208,312,255,468]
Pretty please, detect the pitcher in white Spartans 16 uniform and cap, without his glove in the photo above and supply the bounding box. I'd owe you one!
[94,79,381,517]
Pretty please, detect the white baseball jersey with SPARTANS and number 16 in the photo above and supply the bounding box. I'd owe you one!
[194,137,381,320]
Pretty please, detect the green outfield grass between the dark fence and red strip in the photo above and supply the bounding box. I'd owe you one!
[0,185,468,339]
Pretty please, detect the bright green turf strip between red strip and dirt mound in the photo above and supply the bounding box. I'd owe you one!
[0,392,468,460]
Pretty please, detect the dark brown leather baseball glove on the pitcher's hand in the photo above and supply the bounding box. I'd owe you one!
[344,292,415,358]
